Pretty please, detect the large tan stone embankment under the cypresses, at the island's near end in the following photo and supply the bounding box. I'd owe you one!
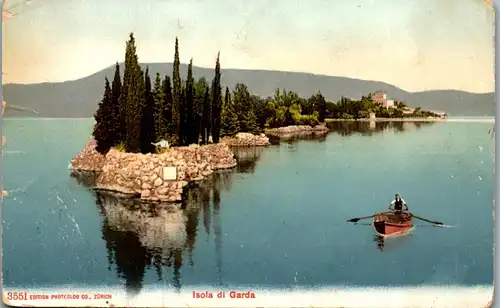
[71,139,237,202]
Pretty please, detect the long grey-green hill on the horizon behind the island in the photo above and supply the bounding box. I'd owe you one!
[3,63,495,118]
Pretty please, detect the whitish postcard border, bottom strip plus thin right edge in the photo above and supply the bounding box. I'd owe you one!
[0,0,500,307]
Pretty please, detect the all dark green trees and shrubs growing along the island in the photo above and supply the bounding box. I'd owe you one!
[93,33,436,153]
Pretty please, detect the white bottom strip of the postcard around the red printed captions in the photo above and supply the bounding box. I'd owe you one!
[0,286,493,308]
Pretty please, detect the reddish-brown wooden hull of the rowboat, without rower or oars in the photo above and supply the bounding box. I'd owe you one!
[373,212,413,237]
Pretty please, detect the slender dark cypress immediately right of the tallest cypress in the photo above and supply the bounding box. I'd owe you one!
[141,68,155,154]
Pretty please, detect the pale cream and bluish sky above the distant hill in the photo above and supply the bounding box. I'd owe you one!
[3,0,494,93]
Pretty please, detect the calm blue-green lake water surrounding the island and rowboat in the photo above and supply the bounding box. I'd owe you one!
[3,118,494,293]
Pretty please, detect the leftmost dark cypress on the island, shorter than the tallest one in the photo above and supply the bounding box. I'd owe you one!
[92,77,114,154]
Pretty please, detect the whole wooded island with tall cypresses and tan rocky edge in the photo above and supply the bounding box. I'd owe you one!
[70,33,442,202]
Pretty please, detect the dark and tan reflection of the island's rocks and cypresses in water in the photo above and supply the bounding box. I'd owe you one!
[71,148,263,296]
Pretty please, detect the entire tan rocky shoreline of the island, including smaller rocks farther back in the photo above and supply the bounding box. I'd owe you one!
[69,125,328,202]
